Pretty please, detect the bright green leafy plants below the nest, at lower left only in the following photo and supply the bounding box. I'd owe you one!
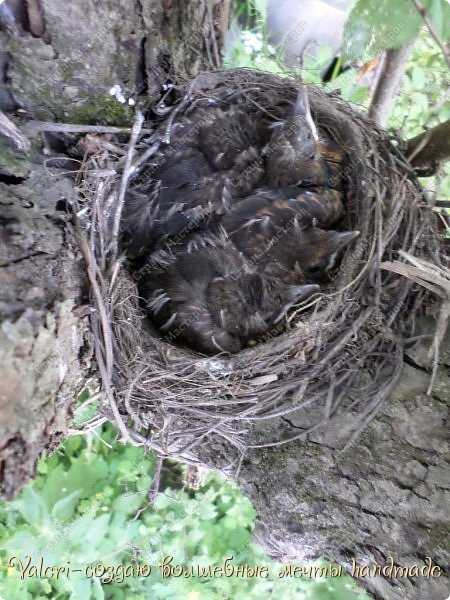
[0,424,366,600]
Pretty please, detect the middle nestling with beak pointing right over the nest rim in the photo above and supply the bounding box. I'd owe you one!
[220,188,359,283]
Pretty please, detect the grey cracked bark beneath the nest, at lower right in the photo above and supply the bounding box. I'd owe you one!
[243,322,450,600]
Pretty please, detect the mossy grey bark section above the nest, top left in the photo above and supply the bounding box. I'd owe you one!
[0,0,230,124]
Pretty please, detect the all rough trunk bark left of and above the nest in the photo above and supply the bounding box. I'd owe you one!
[0,0,229,497]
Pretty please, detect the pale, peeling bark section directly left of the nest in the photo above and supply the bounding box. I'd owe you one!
[0,138,89,497]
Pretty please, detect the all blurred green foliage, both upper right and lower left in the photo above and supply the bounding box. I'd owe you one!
[0,0,450,600]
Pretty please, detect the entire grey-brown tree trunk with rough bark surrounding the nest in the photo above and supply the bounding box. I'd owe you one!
[0,0,450,600]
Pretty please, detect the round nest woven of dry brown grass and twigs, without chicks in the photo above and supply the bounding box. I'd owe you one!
[77,70,448,470]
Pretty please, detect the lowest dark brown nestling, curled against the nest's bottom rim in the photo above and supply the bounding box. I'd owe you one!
[138,234,319,354]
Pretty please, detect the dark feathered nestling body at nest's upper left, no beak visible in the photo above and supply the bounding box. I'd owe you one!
[121,106,270,256]
